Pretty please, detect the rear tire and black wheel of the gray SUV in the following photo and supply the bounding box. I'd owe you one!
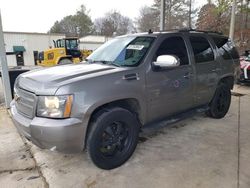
[206,83,231,119]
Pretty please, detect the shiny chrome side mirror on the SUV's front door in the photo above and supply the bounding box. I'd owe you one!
[153,55,180,69]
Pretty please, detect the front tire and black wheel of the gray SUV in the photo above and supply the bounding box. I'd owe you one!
[87,107,140,170]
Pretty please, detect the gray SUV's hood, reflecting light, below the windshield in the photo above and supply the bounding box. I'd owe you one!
[16,64,122,95]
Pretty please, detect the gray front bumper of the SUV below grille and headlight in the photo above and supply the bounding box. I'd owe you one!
[11,102,85,153]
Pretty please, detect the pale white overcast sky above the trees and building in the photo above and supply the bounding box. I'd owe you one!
[0,0,206,32]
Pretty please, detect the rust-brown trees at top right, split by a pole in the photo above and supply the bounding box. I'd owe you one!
[196,0,250,52]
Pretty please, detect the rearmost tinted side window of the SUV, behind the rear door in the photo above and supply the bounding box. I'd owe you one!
[213,37,239,60]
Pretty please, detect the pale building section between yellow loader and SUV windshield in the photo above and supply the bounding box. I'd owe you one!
[80,35,112,51]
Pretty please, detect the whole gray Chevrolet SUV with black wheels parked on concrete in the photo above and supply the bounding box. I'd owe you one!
[11,30,239,169]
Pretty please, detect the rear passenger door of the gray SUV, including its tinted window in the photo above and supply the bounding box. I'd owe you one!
[189,34,221,106]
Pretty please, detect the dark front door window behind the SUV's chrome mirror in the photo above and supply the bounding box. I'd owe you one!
[156,37,189,65]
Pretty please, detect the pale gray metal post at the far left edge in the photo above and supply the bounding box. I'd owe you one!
[0,11,12,108]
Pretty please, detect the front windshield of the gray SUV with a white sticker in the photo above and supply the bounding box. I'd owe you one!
[88,36,154,66]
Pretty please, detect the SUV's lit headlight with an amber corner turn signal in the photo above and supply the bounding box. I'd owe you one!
[37,95,73,118]
